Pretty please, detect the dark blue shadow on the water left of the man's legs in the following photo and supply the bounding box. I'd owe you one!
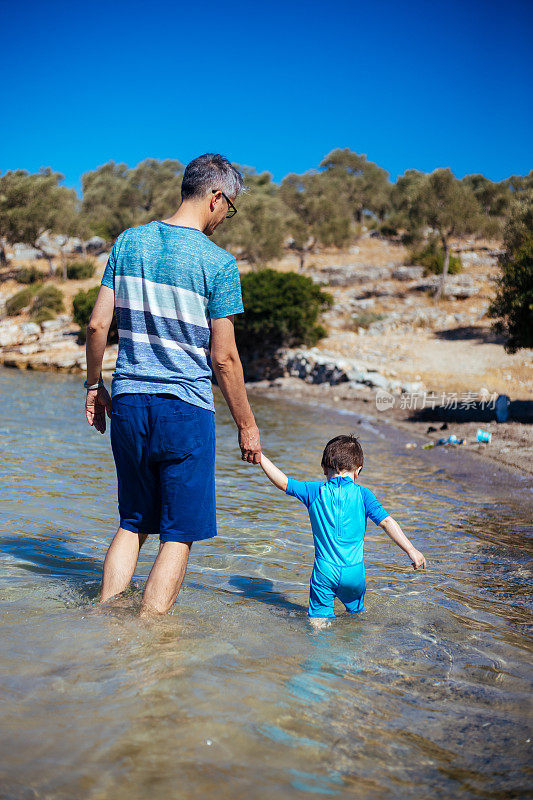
[0,536,102,598]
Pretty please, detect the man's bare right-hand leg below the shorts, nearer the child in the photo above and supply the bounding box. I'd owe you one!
[141,542,191,614]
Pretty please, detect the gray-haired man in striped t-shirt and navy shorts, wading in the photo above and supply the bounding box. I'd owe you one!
[85,153,261,613]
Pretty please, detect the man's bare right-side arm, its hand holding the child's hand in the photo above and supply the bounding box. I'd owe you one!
[211,316,261,464]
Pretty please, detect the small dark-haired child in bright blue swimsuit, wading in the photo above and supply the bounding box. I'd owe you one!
[261,436,426,627]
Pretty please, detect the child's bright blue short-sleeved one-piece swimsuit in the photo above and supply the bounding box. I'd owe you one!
[286,475,389,617]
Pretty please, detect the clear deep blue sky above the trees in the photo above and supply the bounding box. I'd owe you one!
[0,0,533,186]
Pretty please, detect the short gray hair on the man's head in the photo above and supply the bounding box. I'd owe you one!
[181,153,244,200]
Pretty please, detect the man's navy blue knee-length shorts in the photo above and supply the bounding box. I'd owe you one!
[111,394,217,542]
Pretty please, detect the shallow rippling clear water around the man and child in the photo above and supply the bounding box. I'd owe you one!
[0,371,532,800]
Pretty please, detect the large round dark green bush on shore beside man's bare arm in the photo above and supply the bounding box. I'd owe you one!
[235,269,333,364]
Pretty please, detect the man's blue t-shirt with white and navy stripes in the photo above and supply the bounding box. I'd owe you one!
[102,222,243,411]
